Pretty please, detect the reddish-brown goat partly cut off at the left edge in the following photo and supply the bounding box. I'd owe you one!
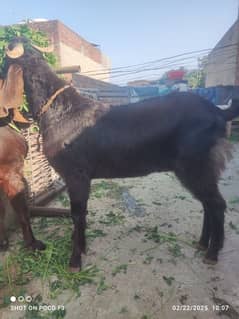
[0,126,45,250]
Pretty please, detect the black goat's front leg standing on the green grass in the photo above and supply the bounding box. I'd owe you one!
[66,174,90,272]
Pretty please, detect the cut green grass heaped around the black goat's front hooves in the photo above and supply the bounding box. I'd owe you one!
[0,225,99,304]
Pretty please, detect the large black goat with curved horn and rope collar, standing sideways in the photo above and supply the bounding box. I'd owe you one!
[6,39,239,269]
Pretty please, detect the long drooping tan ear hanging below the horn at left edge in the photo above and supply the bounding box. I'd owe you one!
[0,64,27,122]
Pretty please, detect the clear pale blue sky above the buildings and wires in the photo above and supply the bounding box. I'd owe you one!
[0,0,239,85]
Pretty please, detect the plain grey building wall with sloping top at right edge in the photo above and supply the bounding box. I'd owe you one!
[205,20,239,87]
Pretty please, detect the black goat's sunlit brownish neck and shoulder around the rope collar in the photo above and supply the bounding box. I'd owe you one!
[24,59,109,158]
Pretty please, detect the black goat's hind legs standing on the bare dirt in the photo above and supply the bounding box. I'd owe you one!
[175,158,226,264]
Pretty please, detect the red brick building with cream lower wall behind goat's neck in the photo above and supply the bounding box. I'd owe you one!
[29,20,111,81]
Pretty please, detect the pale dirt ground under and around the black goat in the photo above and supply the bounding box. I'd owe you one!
[0,144,239,319]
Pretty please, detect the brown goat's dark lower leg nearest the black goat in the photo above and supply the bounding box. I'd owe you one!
[11,191,46,250]
